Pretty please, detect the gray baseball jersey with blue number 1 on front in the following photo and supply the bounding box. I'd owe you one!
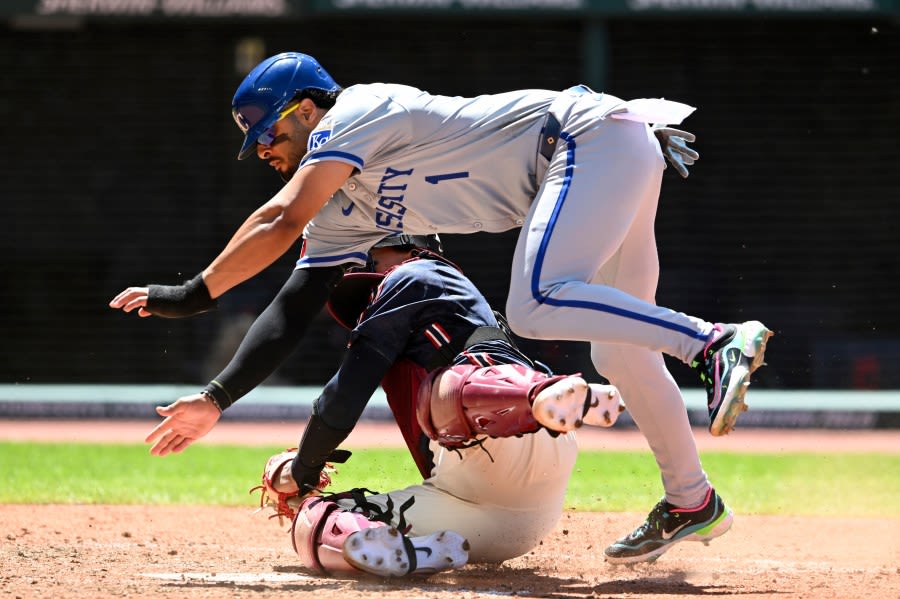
[298,84,559,266]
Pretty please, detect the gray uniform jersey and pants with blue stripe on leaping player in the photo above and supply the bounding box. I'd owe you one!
[298,84,713,507]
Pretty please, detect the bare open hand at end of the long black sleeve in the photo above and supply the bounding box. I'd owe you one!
[144,393,222,456]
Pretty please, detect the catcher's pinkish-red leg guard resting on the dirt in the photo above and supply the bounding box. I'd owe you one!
[291,497,386,573]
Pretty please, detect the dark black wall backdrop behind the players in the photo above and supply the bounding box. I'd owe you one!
[0,0,900,389]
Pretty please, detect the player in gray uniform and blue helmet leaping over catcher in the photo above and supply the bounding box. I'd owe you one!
[110,53,772,563]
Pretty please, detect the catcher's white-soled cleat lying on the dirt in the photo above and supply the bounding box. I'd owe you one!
[343,526,469,577]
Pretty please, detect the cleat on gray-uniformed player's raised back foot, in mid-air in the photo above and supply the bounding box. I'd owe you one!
[691,320,773,437]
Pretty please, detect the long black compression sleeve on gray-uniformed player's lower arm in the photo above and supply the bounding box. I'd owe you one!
[204,266,343,410]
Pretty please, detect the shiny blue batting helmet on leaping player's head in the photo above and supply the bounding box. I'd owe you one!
[231,52,341,160]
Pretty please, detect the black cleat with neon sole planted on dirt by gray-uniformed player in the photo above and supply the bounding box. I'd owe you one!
[604,487,734,564]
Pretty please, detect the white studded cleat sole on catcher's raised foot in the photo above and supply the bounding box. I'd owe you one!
[531,376,625,433]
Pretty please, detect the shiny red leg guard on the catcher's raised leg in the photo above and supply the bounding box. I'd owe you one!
[416,364,566,447]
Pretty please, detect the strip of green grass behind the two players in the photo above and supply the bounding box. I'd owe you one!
[0,443,900,517]
